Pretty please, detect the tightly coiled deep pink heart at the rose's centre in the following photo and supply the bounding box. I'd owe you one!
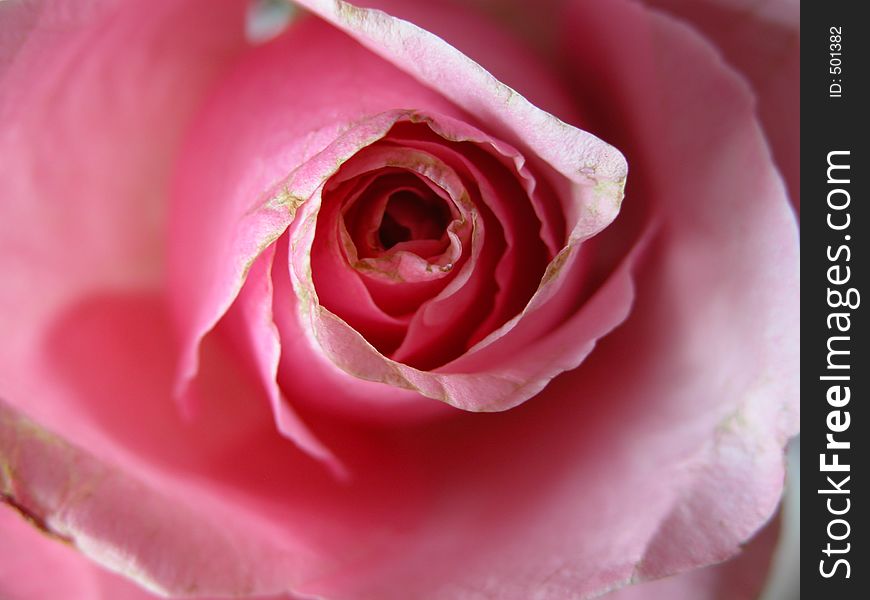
[312,118,552,370]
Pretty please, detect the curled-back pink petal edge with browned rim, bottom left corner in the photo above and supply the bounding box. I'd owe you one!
[0,394,316,595]
